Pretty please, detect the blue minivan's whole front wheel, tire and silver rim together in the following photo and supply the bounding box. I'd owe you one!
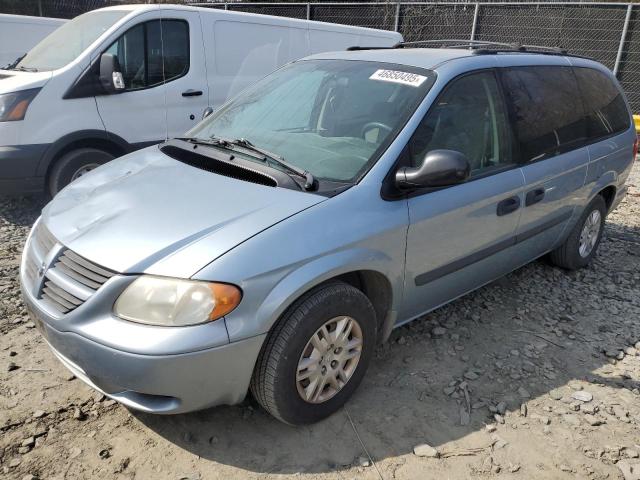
[251,282,376,425]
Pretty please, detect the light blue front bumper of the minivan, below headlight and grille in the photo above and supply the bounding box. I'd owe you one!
[32,312,265,414]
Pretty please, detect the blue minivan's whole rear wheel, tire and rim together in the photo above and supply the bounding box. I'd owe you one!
[550,195,607,270]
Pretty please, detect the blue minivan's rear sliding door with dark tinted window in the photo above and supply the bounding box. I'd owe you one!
[501,66,589,258]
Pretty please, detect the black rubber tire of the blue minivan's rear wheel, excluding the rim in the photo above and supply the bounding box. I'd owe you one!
[549,195,607,270]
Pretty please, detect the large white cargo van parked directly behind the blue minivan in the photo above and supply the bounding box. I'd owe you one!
[0,5,402,195]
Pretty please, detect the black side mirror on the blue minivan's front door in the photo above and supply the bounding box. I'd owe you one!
[396,150,471,190]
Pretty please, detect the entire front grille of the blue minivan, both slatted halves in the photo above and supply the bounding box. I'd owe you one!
[24,223,115,314]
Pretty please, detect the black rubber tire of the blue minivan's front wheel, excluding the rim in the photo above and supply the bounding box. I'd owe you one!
[250,282,377,425]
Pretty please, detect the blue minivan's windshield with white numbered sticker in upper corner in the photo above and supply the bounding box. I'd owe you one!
[187,60,434,182]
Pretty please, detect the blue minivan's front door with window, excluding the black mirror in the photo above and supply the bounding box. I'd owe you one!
[400,70,524,320]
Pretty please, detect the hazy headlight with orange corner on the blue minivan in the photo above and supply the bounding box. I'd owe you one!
[114,276,242,327]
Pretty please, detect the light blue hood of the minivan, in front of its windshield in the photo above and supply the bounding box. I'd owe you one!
[42,146,325,278]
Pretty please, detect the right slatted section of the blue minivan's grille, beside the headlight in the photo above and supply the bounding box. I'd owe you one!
[41,249,115,313]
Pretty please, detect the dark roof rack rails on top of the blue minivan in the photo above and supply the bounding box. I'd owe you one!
[347,38,579,57]
